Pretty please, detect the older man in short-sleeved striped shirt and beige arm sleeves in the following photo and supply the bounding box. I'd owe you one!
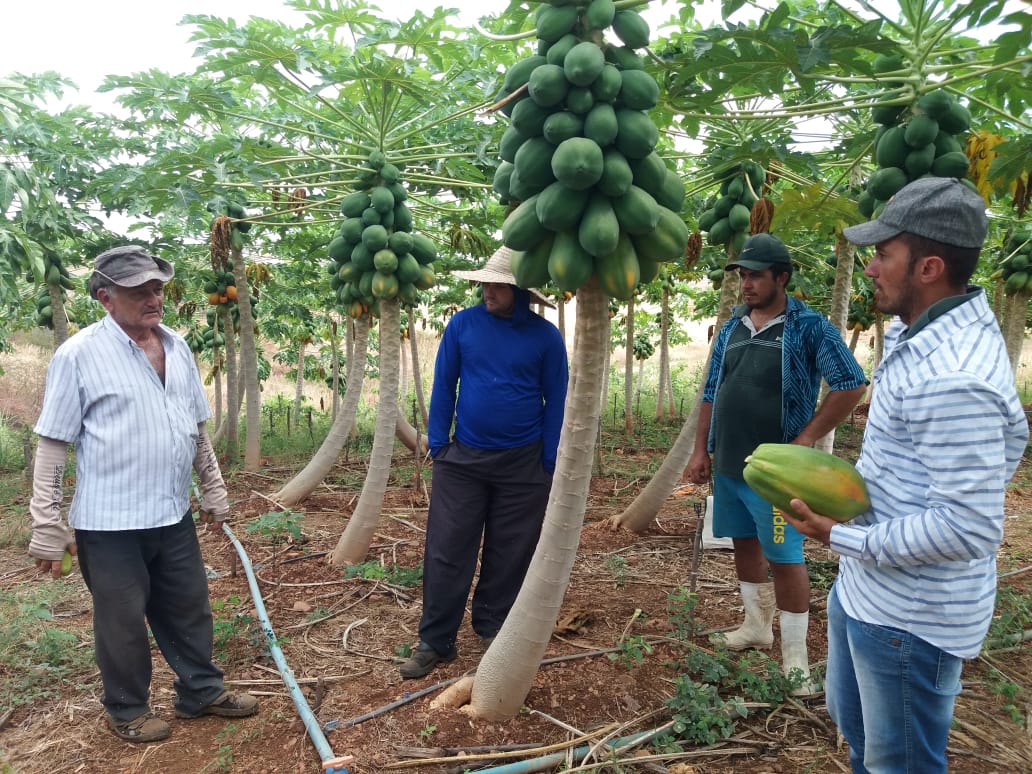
[29,245,258,742]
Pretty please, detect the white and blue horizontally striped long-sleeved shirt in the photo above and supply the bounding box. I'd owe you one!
[831,289,1029,658]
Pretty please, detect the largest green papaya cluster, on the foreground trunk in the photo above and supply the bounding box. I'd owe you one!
[494,0,688,300]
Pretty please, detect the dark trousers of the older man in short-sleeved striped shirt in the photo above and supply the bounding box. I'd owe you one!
[75,511,223,720]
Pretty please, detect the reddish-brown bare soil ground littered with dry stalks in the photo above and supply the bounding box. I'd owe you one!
[0,419,1032,774]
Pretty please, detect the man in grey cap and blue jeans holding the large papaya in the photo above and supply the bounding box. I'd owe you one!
[786,178,1029,774]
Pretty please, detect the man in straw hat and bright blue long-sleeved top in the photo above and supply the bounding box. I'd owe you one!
[400,247,568,678]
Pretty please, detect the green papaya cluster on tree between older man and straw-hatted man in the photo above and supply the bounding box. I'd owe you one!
[326,151,438,318]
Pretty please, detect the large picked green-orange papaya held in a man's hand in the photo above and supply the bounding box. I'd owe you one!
[742,444,871,521]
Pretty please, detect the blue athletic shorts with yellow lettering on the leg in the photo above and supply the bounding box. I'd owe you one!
[713,473,803,565]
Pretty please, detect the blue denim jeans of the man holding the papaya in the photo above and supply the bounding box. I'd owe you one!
[825,586,964,774]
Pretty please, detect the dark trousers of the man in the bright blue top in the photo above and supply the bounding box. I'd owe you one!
[419,442,552,653]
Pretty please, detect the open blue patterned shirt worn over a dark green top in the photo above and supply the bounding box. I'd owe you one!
[703,295,867,452]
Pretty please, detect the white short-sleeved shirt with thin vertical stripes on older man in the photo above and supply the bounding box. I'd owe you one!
[35,316,211,530]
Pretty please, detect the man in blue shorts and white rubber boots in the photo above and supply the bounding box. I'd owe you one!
[684,233,867,696]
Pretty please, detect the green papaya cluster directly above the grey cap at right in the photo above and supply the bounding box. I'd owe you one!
[857,77,974,218]
